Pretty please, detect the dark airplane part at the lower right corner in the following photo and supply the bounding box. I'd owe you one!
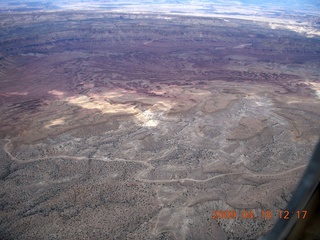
[260,141,320,240]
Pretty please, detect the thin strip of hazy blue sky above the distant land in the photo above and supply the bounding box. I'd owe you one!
[0,0,320,12]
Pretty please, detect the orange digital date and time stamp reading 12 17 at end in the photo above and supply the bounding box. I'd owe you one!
[212,209,308,220]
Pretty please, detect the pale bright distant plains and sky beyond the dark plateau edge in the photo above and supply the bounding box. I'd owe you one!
[0,0,320,37]
